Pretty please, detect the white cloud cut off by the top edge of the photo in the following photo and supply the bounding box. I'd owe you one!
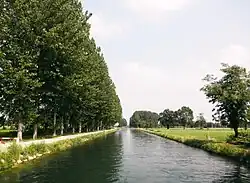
[125,0,193,19]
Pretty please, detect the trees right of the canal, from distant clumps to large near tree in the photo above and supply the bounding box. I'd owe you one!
[130,64,250,137]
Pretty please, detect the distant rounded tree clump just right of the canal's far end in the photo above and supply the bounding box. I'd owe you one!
[130,111,159,128]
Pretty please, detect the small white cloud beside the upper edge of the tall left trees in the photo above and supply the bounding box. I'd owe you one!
[89,14,124,40]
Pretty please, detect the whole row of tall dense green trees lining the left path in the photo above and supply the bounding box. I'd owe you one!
[0,0,122,140]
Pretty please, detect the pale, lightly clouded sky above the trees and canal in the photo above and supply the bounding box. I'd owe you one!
[83,0,250,121]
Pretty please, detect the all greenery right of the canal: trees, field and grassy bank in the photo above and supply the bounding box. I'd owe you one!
[130,63,250,165]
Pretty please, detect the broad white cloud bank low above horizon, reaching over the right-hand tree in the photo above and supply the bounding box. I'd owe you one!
[111,44,250,121]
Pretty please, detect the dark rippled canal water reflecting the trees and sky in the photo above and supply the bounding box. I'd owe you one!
[0,129,250,183]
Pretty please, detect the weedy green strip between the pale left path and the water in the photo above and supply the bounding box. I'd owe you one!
[0,129,116,172]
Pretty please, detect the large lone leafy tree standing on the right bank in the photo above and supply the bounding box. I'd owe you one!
[201,64,250,137]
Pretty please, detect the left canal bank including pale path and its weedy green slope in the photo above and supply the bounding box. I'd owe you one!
[0,129,116,173]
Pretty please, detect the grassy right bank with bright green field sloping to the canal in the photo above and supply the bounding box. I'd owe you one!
[141,128,250,166]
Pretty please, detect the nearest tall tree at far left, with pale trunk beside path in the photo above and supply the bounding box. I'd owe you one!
[0,0,41,140]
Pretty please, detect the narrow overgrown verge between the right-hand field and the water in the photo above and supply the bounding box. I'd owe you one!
[142,129,250,167]
